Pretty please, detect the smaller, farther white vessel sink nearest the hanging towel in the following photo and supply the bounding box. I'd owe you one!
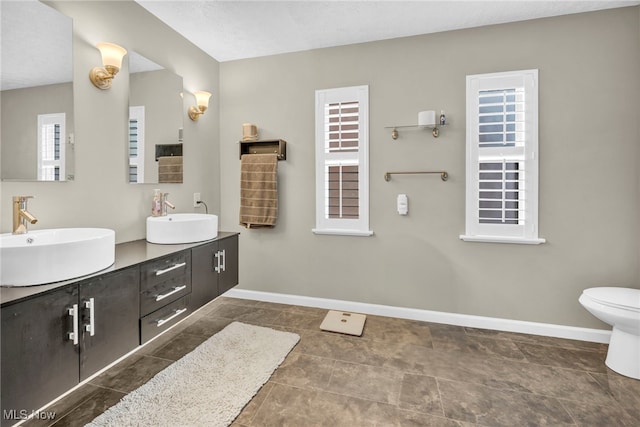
[147,213,218,245]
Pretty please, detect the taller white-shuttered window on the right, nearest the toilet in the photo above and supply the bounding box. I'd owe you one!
[460,70,544,244]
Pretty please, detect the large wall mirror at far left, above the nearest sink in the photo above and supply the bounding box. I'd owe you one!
[0,0,74,181]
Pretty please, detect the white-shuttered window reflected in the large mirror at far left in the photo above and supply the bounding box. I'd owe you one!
[38,113,66,181]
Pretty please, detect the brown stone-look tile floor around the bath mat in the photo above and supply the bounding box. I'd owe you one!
[25,297,640,427]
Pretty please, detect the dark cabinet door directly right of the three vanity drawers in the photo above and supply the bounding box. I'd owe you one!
[190,242,218,310]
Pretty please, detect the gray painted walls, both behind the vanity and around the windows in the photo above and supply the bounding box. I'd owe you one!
[0,1,640,327]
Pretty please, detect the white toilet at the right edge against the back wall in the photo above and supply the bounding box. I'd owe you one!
[578,287,640,380]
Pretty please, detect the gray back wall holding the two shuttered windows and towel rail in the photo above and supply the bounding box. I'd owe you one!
[220,7,640,327]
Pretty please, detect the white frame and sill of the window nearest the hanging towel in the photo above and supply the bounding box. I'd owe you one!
[312,85,373,236]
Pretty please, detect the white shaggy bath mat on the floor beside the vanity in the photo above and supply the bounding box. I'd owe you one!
[88,322,300,427]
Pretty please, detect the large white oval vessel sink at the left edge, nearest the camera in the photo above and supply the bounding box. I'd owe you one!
[0,228,116,286]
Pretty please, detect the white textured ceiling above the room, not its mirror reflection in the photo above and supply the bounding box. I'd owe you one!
[137,0,640,62]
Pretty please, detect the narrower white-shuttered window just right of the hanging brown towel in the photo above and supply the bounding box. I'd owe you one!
[313,86,373,236]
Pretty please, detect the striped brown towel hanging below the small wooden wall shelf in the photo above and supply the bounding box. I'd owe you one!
[240,153,278,228]
